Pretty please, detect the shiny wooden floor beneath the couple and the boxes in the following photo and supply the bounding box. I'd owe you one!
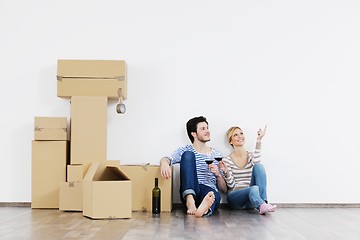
[0,207,360,240]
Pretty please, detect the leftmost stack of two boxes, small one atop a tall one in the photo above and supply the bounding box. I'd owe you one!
[31,117,69,208]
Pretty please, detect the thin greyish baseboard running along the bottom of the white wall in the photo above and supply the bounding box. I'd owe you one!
[0,202,360,208]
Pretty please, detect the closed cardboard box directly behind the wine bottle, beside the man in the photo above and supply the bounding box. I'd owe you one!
[120,164,172,212]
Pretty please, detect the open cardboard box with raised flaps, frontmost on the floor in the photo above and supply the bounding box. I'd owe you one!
[83,162,132,219]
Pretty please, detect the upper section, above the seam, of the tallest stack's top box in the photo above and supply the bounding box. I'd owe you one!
[57,59,126,80]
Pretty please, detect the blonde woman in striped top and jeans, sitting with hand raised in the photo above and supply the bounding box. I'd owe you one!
[219,126,276,215]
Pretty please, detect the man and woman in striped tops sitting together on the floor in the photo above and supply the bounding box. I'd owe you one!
[160,116,276,217]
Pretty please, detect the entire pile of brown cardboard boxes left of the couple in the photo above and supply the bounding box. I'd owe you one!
[31,60,172,219]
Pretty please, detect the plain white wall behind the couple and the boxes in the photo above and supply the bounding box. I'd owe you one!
[0,0,360,203]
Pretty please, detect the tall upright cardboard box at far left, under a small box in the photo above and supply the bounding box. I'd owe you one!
[31,141,68,208]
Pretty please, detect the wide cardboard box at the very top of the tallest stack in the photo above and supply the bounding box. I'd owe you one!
[57,60,127,99]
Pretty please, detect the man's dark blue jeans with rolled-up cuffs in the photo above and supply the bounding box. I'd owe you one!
[180,151,221,215]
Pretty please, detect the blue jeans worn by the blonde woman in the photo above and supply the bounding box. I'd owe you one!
[227,163,267,209]
